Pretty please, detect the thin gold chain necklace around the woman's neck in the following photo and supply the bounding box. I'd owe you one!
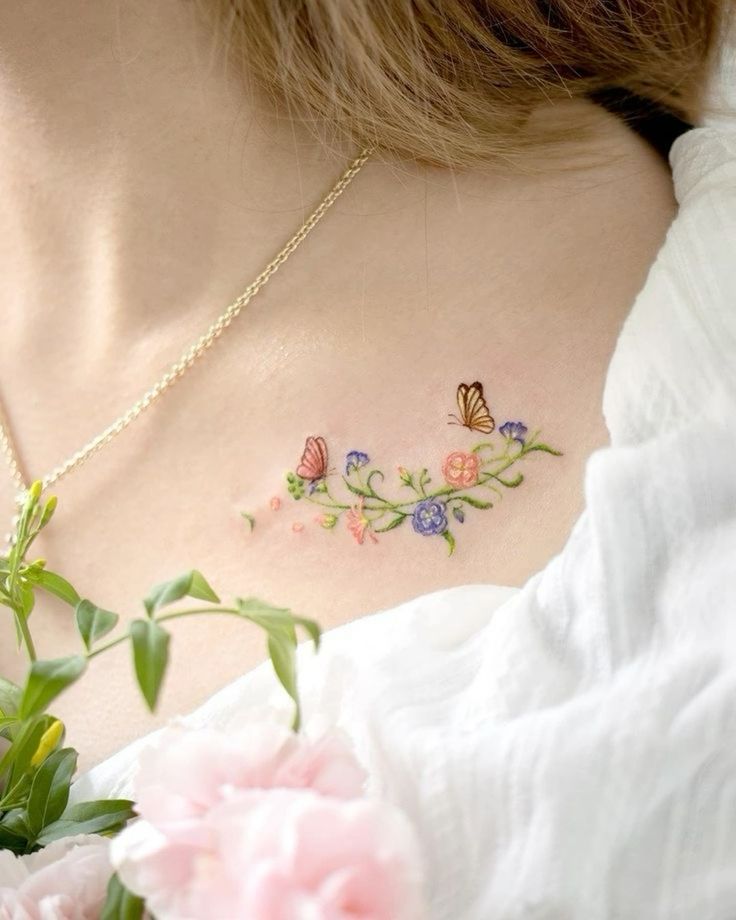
[0,147,374,540]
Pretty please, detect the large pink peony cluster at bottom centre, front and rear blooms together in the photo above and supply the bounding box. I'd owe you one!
[111,723,421,920]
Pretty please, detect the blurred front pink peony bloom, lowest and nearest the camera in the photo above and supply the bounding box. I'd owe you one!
[112,789,423,920]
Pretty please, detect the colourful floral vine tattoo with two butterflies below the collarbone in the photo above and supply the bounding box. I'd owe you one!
[244,382,562,555]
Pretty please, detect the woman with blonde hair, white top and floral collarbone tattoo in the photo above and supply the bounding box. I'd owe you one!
[0,0,736,918]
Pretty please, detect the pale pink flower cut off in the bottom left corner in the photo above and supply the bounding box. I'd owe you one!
[0,834,113,920]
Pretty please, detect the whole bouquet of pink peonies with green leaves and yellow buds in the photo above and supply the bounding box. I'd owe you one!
[0,483,423,920]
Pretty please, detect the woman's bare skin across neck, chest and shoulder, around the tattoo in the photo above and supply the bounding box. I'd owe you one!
[0,0,676,765]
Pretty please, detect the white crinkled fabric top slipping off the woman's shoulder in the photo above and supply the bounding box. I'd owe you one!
[74,21,736,920]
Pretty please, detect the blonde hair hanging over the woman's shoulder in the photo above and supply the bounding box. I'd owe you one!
[203,0,731,167]
